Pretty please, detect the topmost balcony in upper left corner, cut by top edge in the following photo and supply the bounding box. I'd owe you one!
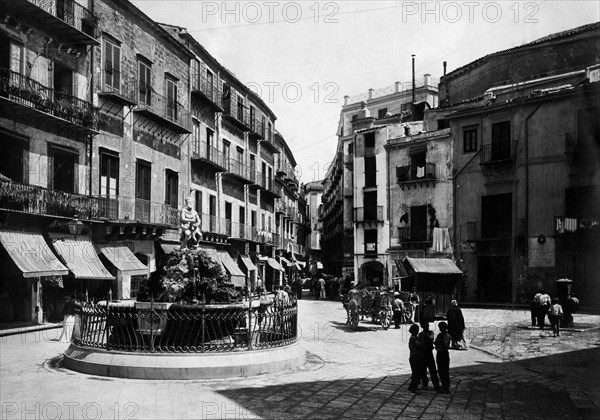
[10,0,100,45]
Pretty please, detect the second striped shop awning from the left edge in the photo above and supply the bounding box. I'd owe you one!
[48,233,115,280]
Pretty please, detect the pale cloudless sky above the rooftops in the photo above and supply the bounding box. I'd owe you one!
[132,0,600,183]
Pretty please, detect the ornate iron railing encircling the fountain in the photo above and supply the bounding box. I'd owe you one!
[73,302,298,353]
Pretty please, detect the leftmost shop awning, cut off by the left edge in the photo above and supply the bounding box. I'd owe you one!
[0,230,69,278]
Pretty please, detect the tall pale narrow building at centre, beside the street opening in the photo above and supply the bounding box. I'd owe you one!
[321,75,437,284]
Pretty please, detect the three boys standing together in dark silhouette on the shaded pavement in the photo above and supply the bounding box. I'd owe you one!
[408,320,451,394]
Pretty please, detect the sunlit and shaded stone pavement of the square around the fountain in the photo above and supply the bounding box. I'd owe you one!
[0,299,600,419]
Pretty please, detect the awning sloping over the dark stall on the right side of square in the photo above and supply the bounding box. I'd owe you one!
[403,257,462,293]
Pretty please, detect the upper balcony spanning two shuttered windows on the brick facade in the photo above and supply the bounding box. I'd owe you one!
[133,86,192,134]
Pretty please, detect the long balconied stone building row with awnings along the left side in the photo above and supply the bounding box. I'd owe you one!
[0,0,298,322]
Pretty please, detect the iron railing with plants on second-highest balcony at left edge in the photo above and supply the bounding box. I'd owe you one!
[0,68,98,130]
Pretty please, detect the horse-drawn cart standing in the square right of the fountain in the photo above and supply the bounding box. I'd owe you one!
[342,288,393,330]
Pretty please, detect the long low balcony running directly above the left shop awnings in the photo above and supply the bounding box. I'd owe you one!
[0,181,179,226]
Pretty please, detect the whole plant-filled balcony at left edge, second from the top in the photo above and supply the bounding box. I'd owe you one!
[0,68,98,135]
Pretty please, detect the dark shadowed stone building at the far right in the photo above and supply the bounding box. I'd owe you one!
[438,23,600,307]
